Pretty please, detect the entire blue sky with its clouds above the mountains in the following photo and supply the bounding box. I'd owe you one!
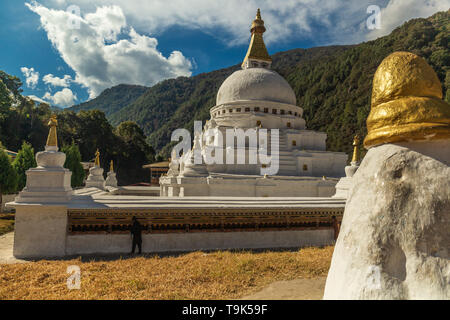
[0,0,450,107]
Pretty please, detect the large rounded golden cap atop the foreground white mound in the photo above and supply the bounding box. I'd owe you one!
[364,52,450,148]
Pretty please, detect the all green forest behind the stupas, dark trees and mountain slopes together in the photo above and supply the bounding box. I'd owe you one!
[0,11,450,184]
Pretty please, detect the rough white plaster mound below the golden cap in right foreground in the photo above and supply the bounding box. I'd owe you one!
[324,141,450,299]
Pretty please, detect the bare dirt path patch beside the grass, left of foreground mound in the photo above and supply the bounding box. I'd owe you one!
[241,277,327,300]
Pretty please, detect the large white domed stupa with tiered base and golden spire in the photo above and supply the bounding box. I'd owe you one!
[160,10,347,197]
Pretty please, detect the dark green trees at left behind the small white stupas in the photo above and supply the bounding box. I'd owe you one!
[0,71,155,185]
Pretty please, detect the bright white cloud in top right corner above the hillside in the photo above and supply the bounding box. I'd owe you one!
[367,0,450,39]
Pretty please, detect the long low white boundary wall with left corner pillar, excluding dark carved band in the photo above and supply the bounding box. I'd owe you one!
[8,194,345,259]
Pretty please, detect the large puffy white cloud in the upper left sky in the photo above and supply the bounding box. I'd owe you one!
[26,2,192,98]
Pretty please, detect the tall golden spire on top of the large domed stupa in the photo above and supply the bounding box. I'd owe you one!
[242,9,272,69]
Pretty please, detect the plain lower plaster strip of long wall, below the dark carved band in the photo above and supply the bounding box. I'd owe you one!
[67,229,334,255]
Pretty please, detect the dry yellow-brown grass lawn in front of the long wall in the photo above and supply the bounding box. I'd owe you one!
[0,247,333,299]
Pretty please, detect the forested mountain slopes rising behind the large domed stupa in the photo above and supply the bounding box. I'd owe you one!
[94,11,450,157]
